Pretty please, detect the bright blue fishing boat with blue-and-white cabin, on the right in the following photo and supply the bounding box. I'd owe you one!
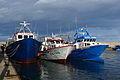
[68,27,108,61]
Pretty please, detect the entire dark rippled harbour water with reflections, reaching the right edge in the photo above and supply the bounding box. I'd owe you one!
[1,51,120,80]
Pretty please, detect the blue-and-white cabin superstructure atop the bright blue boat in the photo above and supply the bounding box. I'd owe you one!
[73,28,100,48]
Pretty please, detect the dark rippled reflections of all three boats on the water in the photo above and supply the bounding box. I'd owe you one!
[11,60,103,80]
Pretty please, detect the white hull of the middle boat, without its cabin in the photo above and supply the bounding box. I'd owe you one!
[40,46,74,60]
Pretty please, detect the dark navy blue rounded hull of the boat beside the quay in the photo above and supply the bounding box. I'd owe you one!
[6,38,41,62]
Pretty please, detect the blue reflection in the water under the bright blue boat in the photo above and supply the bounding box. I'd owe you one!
[67,61,104,74]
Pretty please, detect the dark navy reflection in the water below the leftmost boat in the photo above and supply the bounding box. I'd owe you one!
[14,61,41,80]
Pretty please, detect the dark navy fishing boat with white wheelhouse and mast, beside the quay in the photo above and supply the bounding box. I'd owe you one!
[6,21,42,63]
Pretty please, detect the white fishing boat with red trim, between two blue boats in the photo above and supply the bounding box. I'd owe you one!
[40,33,75,62]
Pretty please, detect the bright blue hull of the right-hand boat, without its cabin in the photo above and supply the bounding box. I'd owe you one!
[68,45,108,61]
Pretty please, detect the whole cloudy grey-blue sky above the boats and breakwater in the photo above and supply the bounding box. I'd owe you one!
[0,0,120,41]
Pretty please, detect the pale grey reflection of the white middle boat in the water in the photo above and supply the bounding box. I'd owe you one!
[42,61,73,80]
